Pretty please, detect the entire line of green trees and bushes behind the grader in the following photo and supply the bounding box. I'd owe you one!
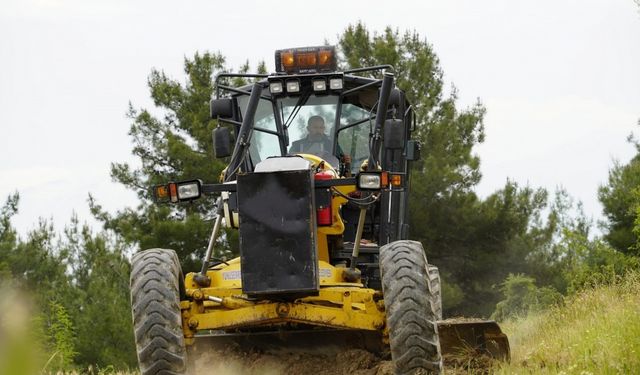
[0,23,640,369]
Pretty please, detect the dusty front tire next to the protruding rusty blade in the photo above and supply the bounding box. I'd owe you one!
[380,241,442,375]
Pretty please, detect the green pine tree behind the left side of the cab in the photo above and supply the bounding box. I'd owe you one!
[90,53,231,272]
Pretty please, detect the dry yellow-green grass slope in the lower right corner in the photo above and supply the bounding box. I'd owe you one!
[493,272,640,375]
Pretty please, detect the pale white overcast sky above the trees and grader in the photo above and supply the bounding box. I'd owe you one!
[0,0,640,234]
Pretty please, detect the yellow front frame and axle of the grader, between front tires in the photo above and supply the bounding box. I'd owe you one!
[180,154,385,344]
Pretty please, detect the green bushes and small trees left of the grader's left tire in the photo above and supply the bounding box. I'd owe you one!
[0,194,136,374]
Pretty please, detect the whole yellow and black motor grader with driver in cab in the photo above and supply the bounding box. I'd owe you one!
[131,46,509,375]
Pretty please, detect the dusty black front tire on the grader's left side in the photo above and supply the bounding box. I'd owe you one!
[130,249,187,375]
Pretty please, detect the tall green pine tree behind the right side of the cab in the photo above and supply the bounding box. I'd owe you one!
[339,23,548,316]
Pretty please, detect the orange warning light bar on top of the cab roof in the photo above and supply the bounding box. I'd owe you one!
[276,46,337,74]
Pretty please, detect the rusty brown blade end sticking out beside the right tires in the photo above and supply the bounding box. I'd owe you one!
[438,319,511,361]
